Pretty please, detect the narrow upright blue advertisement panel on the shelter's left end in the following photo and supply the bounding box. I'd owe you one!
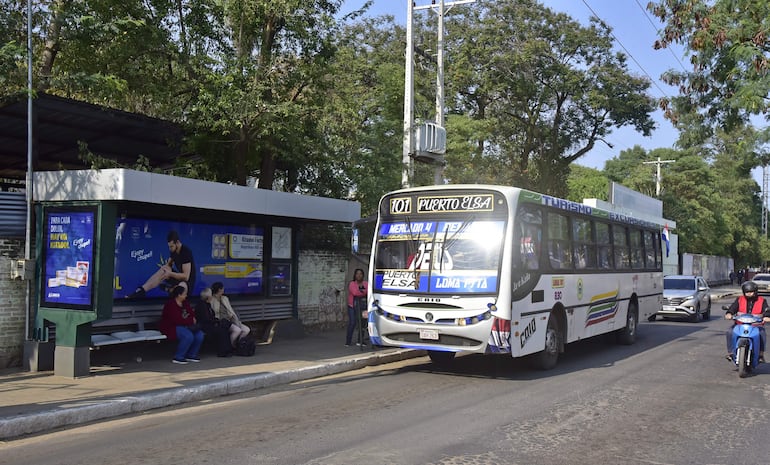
[42,210,96,310]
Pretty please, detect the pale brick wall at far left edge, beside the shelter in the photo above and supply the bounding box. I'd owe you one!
[0,238,27,369]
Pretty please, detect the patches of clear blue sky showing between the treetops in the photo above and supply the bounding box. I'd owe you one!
[342,0,689,169]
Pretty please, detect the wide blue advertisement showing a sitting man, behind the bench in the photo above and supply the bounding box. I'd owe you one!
[113,218,264,299]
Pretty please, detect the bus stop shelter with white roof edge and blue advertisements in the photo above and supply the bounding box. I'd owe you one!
[34,169,360,377]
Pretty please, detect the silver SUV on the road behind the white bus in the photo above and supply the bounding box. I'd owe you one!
[650,275,711,322]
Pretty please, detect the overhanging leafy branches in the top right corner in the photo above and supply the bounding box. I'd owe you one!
[648,0,770,135]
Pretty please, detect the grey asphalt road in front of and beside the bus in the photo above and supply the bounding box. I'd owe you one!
[0,301,770,465]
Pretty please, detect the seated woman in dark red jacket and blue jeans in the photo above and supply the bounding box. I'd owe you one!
[160,283,204,365]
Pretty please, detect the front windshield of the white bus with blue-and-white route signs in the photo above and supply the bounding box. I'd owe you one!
[374,217,505,294]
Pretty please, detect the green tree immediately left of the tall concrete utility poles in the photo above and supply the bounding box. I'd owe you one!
[320,17,405,216]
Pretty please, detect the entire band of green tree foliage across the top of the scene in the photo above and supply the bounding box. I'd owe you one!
[0,0,770,264]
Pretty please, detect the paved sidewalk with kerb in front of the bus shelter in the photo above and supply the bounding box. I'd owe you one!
[0,329,424,440]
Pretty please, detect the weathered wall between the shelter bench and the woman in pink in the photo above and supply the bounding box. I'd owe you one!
[297,250,352,332]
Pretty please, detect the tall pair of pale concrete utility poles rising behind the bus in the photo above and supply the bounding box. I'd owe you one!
[401,0,476,187]
